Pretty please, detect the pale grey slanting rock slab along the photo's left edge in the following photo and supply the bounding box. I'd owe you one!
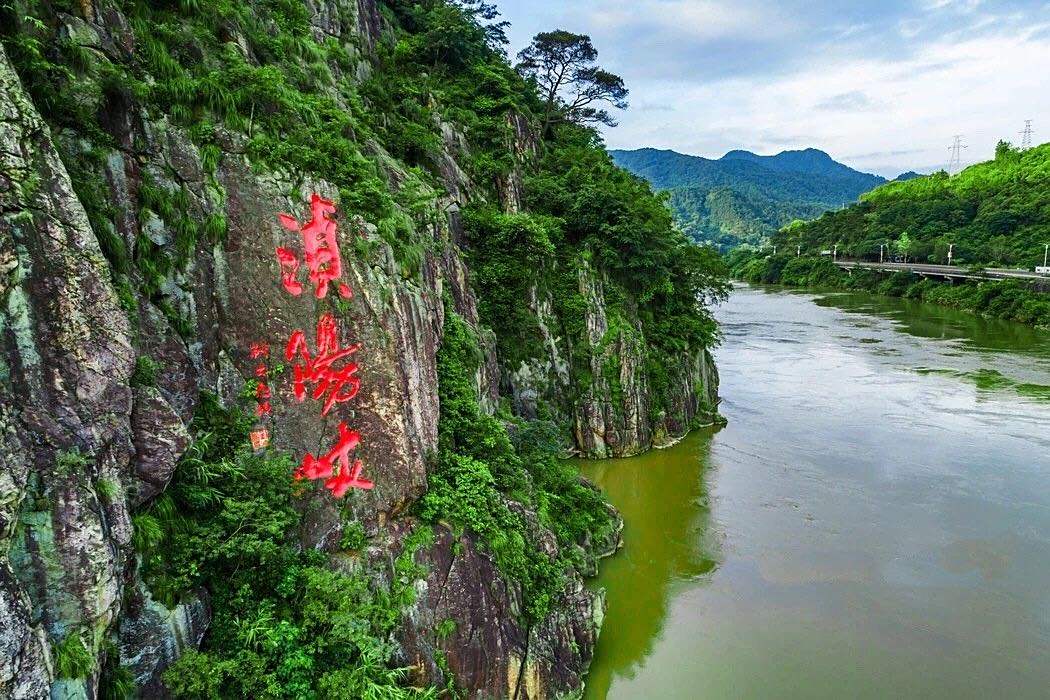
[0,41,134,697]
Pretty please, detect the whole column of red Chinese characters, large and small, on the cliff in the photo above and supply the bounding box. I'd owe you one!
[264,194,375,499]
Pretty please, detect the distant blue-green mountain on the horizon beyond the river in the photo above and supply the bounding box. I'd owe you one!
[611,148,886,251]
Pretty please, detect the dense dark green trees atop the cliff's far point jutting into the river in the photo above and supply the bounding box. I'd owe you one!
[464,131,727,413]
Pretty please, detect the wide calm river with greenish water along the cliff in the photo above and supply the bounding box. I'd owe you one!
[581,285,1050,699]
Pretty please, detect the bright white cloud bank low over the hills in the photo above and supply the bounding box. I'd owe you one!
[607,29,1050,174]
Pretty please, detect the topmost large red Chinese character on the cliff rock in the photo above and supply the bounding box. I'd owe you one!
[277,194,352,299]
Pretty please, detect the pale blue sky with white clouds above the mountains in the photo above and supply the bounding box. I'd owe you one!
[495,0,1050,177]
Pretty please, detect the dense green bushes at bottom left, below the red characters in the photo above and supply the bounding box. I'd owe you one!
[134,396,433,700]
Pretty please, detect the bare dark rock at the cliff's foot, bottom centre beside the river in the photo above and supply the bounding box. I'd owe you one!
[395,518,605,700]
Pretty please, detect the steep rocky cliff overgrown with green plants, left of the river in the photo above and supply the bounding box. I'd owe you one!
[0,0,726,699]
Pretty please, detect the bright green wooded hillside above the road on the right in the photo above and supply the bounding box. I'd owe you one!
[773,143,1050,269]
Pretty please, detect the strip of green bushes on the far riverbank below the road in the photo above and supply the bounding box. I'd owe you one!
[729,252,1050,327]
